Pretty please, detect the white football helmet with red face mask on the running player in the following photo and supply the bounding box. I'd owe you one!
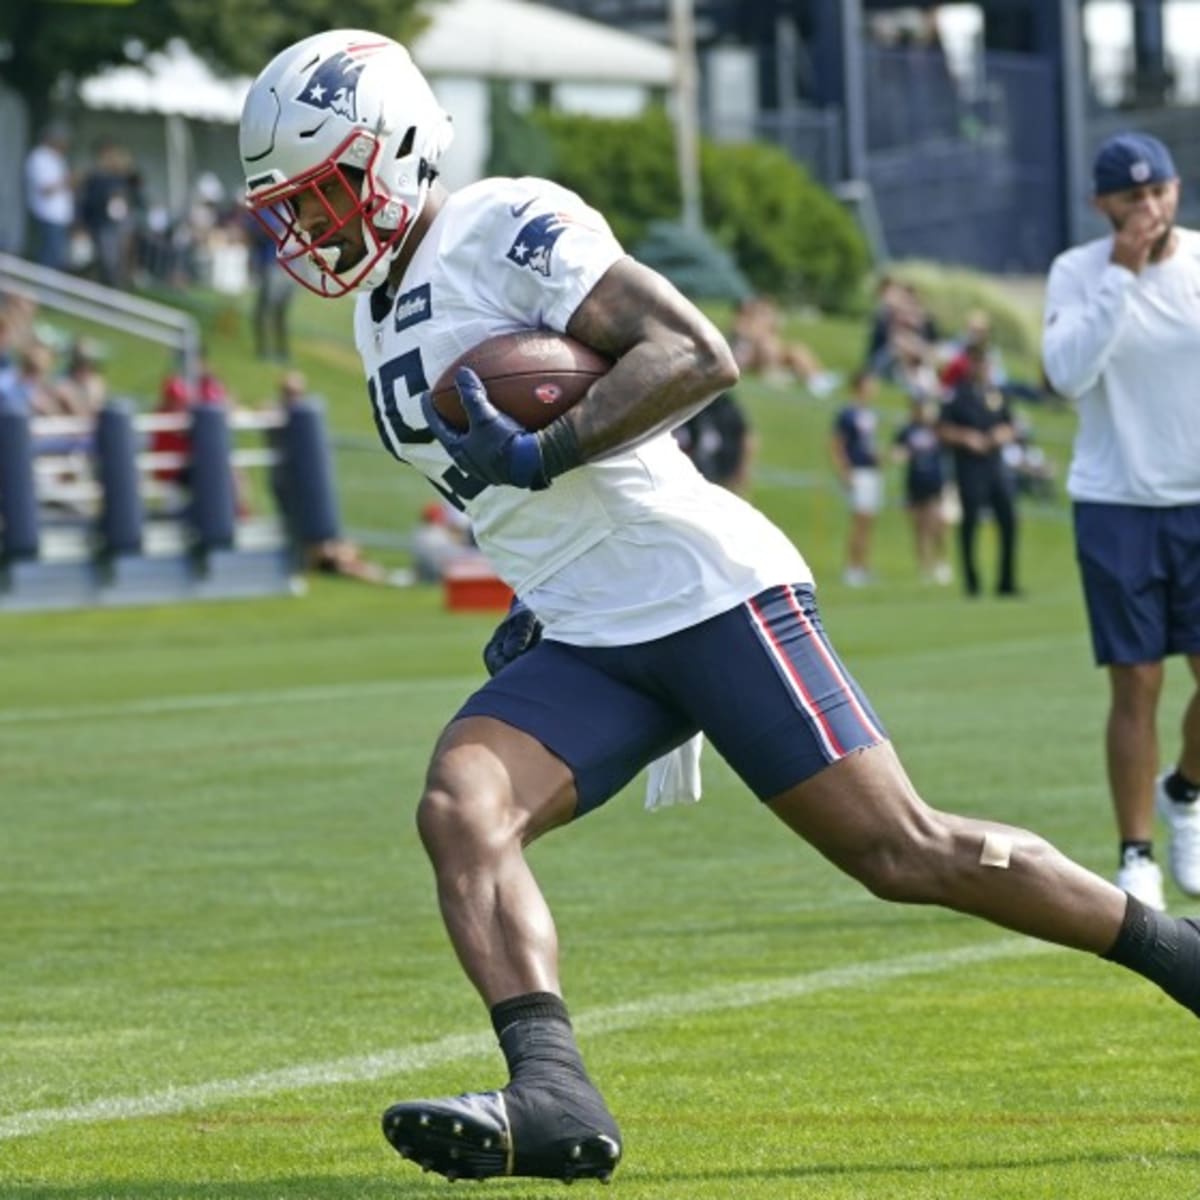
[239,29,454,296]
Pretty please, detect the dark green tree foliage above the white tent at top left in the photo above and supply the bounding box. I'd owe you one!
[0,0,438,127]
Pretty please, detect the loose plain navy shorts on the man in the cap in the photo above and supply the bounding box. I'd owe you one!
[1074,503,1200,666]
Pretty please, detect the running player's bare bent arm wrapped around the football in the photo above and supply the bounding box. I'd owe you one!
[560,258,738,461]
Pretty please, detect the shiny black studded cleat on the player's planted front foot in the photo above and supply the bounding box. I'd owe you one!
[383,1084,620,1183]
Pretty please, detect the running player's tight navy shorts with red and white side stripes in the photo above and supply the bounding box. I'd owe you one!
[458,586,887,815]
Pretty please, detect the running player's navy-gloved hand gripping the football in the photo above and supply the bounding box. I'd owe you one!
[421,367,550,492]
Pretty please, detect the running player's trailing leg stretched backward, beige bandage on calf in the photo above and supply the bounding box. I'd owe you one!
[677,588,1200,1012]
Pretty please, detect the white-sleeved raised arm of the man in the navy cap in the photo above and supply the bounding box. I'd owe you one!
[1042,259,1136,398]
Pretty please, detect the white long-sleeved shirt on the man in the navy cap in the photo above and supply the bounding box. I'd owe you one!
[1043,229,1200,508]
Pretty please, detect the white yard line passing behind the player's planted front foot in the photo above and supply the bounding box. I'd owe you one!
[0,937,1049,1141]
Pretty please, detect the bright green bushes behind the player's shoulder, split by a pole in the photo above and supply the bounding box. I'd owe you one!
[488,106,868,311]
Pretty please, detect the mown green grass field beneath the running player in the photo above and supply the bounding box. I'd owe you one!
[0,292,1200,1200]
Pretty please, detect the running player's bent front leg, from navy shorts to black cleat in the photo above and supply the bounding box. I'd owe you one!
[383,642,691,1180]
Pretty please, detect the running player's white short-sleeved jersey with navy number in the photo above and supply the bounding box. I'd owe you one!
[355,179,811,646]
